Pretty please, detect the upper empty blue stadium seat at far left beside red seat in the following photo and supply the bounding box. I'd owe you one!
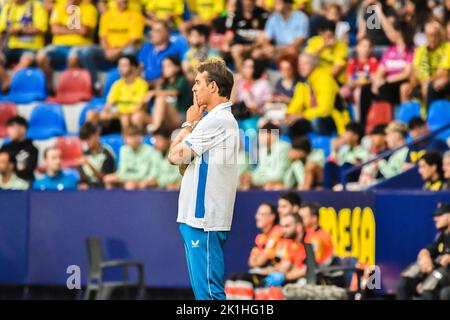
[1,68,47,103]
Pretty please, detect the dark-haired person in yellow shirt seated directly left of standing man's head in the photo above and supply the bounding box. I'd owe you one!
[100,55,148,130]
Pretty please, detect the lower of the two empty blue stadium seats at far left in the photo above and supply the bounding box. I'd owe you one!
[28,103,66,140]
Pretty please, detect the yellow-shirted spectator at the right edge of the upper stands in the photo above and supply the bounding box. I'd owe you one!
[413,20,450,105]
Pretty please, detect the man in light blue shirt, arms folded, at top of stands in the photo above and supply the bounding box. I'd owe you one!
[259,0,309,58]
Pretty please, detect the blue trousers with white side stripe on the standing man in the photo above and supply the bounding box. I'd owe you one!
[180,223,229,300]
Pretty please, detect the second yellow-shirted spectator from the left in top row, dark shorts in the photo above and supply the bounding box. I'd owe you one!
[37,0,97,89]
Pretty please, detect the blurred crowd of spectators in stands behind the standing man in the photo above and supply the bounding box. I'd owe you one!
[0,0,450,191]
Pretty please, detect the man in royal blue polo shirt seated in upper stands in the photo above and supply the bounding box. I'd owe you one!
[138,21,188,85]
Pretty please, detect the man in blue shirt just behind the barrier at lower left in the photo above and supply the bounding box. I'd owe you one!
[33,147,78,191]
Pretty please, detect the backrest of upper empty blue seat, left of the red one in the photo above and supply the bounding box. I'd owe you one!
[10,68,46,100]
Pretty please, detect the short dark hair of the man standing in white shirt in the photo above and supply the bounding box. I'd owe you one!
[197,58,234,99]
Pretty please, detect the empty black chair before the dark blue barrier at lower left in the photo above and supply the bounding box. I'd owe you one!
[84,238,145,300]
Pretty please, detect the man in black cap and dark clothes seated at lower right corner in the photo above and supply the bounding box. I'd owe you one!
[397,203,450,300]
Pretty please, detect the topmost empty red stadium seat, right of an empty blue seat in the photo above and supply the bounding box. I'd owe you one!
[48,68,92,104]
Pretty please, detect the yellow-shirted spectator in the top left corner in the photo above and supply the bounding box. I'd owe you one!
[0,0,48,90]
